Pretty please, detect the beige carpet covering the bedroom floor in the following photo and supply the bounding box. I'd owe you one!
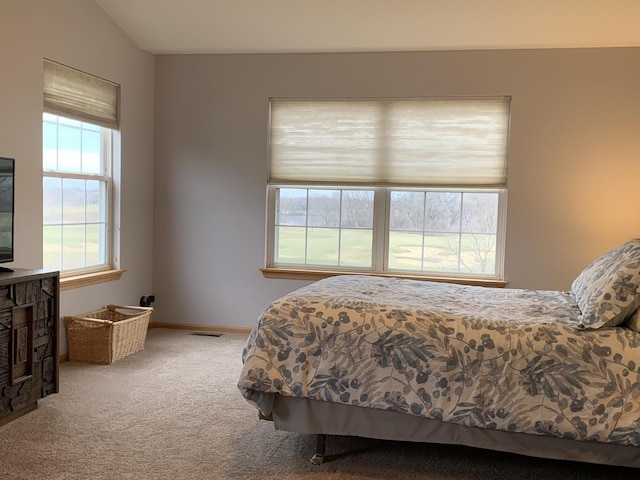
[0,329,640,480]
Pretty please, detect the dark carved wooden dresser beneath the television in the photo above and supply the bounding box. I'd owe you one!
[0,269,60,426]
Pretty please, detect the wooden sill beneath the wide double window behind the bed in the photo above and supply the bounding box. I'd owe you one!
[260,267,507,288]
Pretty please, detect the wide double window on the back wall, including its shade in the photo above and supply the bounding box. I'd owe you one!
[267,97,510,279]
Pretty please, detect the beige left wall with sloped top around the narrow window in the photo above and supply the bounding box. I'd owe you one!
[0,0,155,349]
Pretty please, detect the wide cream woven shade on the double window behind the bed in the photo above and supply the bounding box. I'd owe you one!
[269,97,510,188]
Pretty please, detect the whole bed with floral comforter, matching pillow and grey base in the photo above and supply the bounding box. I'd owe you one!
[238,239,640,468]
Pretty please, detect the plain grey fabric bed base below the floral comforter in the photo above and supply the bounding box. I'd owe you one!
[273,395,640,468]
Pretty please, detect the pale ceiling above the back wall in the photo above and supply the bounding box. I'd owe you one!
[94,0,640,54]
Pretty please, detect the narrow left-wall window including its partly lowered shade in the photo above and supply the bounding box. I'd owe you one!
[42,60,119,276]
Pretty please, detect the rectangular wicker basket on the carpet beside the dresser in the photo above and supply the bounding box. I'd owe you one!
[64,305,153,364]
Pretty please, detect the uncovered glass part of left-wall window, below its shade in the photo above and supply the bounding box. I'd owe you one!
[42,113,112,272]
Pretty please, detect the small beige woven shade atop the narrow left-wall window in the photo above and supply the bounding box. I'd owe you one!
[44,59,120,130]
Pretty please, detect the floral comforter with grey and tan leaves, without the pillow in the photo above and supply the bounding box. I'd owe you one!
[238,276,640,445]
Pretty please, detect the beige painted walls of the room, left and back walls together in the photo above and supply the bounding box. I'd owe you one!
[0,0,640,332]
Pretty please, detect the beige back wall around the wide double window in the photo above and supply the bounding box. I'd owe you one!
[154,48,640,326]
